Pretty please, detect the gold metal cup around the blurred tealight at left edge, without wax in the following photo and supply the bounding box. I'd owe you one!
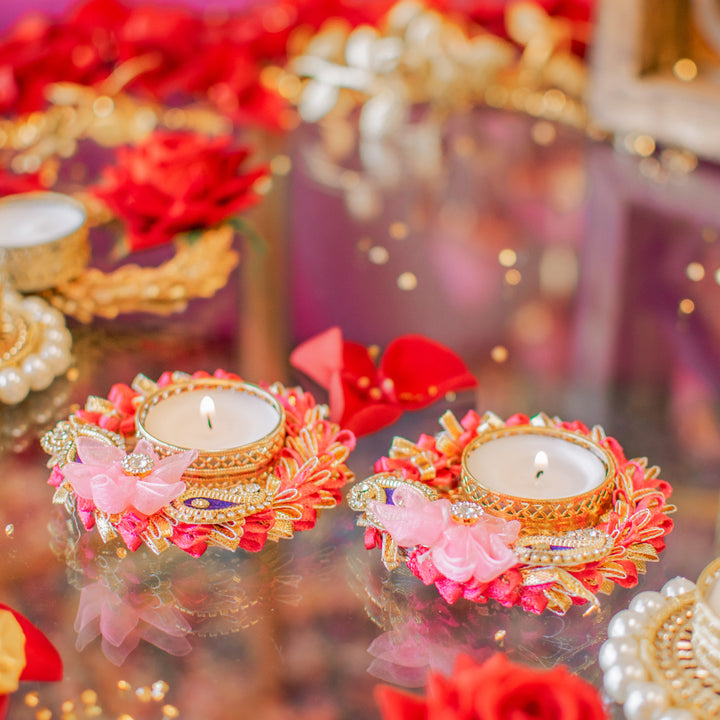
[0,191,90,292]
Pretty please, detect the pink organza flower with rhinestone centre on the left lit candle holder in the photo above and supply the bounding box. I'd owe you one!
[62,437,197,515]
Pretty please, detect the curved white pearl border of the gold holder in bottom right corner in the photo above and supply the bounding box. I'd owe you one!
[598,577,696,720]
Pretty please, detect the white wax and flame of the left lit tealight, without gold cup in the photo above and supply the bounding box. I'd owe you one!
[143,387,281,453]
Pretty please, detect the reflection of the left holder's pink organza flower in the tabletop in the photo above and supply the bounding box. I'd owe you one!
[75,582,192,666]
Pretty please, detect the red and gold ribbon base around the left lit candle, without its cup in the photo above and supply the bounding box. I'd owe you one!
[42,370,355,557]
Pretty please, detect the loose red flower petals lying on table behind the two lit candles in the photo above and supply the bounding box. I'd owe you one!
[290,327,477,435]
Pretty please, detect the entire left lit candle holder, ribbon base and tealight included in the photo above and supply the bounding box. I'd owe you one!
[43,371,355,556]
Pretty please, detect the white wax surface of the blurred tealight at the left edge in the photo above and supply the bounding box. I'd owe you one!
[0,193,85,248]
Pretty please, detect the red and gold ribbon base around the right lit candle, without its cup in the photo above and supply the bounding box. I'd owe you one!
[348,411,675,615]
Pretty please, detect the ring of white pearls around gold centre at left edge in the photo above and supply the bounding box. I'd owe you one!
[0,290,72,405]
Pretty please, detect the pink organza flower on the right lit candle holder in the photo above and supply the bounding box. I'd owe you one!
[370,486,520,583]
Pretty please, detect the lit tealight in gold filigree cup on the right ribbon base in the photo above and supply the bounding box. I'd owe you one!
[462,424,617,533]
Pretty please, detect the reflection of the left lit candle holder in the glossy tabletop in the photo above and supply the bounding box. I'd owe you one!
[50,514,296,665]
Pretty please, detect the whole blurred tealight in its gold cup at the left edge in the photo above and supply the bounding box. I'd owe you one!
[0,192,90,292]
